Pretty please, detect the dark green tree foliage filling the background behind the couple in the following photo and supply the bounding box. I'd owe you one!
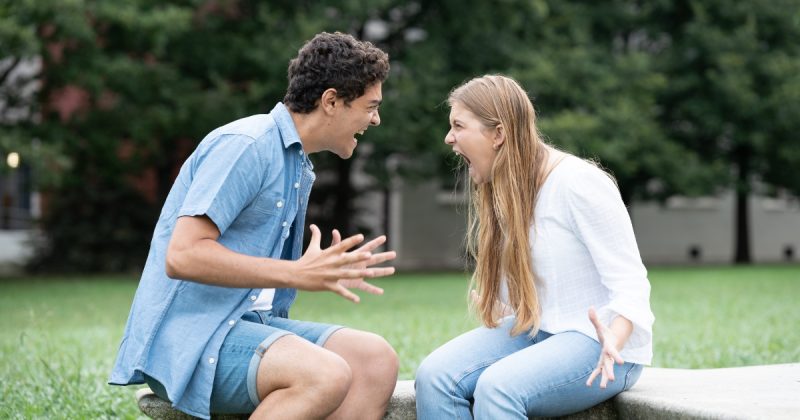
[0,0,800,271]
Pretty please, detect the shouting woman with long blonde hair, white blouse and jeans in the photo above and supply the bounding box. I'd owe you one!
[416,76,654,420]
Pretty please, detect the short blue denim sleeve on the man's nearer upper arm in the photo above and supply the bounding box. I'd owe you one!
[178,136,265,234]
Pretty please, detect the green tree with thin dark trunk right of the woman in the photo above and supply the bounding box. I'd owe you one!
[652,0,800,263]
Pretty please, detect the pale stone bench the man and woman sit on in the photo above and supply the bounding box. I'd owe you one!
[136,363,800,420]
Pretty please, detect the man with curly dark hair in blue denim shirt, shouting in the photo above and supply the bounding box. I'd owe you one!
[109,32,398,419]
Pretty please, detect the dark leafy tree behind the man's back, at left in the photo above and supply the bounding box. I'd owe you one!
[0,0,404,271]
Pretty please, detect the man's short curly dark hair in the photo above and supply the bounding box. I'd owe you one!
[283,32,389,114]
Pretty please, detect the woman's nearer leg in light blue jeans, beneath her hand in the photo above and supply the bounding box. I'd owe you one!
[475,332,641,418]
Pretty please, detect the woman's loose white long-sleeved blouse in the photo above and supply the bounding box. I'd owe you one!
[530,156,655,364]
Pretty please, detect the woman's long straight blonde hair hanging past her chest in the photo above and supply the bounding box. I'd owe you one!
[447,75,548,335]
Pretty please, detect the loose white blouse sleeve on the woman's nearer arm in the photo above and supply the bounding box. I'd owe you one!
[567,167,655,348]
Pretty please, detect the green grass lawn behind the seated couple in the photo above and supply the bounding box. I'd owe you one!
[0,266,800,419]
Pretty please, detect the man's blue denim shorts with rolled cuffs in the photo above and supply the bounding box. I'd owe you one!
[145,311,342,414]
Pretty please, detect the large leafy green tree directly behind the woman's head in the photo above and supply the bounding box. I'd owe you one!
[370,0,717,203]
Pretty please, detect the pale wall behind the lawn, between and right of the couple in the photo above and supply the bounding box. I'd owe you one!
[389,182,800,270]
